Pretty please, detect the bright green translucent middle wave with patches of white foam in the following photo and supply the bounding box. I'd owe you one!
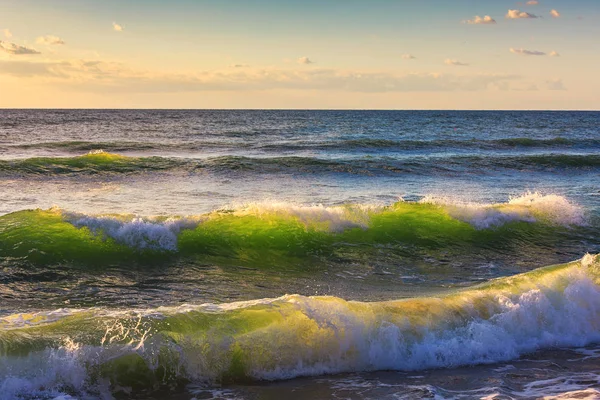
[0,193,594,264]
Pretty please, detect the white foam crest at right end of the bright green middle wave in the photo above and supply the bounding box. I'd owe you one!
[421,193,586,229]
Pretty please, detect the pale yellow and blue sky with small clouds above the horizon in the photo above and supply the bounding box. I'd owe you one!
[0,0,600,110]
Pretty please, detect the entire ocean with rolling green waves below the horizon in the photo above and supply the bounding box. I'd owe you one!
[0,110,600,400]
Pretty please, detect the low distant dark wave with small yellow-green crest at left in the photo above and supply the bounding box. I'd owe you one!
[0,151,600,176]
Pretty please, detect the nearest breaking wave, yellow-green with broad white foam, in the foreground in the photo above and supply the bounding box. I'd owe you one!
[0,255,600,397]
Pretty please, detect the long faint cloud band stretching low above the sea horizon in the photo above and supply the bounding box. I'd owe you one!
[0,60,520,93]
